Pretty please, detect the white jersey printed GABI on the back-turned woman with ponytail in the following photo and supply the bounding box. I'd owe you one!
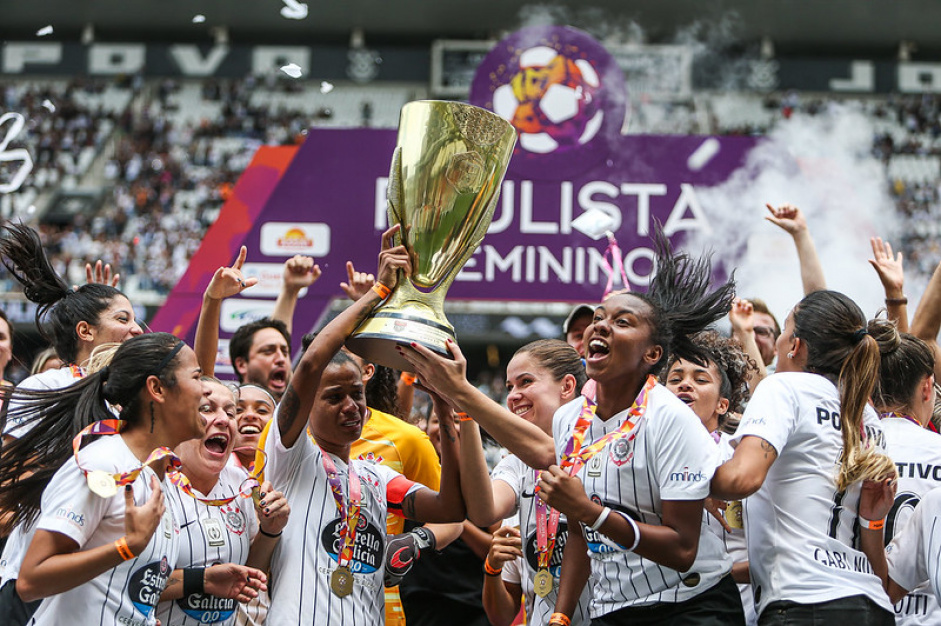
[732,372,892,615]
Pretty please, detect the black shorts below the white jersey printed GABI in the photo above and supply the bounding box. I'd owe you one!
[758,596,895,626]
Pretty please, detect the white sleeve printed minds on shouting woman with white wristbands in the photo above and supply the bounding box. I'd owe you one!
[645,392,719,500]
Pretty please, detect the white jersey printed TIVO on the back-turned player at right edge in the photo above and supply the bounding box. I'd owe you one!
[882,417,941,626]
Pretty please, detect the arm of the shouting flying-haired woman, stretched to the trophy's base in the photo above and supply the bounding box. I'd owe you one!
[401,339,555,469]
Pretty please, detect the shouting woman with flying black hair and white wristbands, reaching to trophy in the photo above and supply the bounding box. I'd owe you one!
[406,235,744,626]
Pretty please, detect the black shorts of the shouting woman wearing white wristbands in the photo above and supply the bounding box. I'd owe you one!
[591,576,745,626]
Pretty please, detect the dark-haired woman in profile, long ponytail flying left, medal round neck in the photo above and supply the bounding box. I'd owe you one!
[0,333,264,626]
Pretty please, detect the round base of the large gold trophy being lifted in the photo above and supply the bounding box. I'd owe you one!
[346,311,455,372]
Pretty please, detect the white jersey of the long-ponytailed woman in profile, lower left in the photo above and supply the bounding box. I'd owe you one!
[28,435,180,626]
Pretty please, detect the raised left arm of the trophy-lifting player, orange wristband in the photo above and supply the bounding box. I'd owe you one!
[277,224,410,448]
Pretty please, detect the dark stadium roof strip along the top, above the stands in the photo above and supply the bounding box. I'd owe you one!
[0,0,941,55]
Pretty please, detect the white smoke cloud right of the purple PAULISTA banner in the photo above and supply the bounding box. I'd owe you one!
[687,104,917,321]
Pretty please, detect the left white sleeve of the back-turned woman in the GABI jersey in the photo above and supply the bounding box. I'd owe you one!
[732,376,798,456]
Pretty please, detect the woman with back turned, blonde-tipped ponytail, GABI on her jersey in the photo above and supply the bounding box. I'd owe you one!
[712,291,898,626]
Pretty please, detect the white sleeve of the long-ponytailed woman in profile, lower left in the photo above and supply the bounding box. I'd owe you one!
[36,458,111,548]
